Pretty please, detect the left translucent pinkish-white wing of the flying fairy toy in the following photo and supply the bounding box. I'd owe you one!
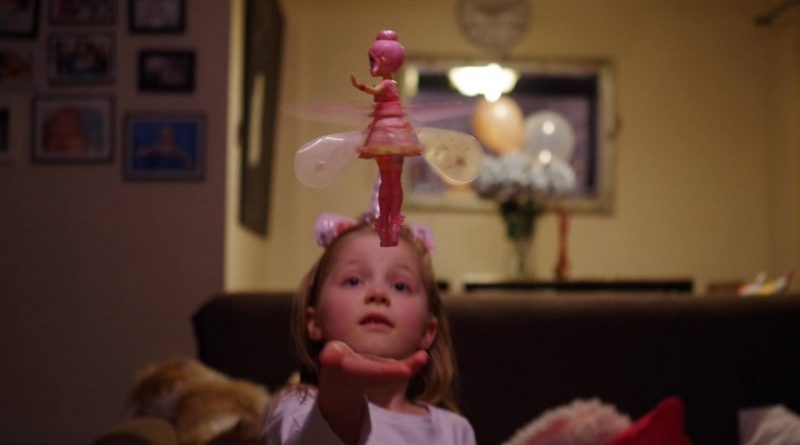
[294,131,364,187]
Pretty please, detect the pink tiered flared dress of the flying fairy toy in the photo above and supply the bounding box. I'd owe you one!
[358,79,422,159]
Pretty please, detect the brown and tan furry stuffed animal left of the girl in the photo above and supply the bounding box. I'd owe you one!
[128,358,270,445]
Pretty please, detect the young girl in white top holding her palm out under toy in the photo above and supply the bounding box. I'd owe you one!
[265,219,475,445]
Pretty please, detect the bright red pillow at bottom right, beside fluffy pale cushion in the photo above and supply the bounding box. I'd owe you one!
[611,397,692,445]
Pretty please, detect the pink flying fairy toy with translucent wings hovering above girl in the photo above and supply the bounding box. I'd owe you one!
[295,30,483,246]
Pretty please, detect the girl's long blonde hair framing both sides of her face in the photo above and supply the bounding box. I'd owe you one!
[292,224,459,412]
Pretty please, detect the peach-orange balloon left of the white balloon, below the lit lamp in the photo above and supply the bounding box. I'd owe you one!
[472,96,522,155]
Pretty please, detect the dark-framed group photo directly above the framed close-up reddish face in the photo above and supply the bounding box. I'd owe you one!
[47,33,114,85]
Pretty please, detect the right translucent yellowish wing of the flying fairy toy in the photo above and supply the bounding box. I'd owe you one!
[417,127,483,184]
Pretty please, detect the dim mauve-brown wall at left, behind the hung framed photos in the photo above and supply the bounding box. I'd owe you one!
[0,0,229,444]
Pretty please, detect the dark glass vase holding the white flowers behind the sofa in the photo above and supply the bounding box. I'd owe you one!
[500,199,542,276]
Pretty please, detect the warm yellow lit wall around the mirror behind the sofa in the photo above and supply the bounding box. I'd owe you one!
[226,0,800,292]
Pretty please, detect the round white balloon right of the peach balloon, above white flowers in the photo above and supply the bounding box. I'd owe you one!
[523,110,575,163]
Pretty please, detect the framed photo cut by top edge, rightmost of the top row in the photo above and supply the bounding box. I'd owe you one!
[128,0,186,33]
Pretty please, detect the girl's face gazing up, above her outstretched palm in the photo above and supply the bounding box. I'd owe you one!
[307,232,437,359]
